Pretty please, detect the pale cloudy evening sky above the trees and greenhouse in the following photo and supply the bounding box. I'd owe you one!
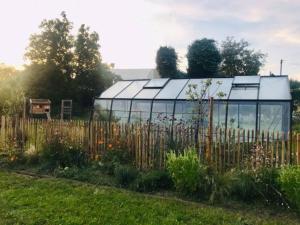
[0,0,300,80]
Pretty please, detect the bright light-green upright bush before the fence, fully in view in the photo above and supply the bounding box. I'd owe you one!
[167,148,205,194]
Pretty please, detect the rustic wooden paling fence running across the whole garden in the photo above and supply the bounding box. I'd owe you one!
[0,116,300,170]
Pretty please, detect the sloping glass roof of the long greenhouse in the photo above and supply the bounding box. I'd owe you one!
[100,76,292,100]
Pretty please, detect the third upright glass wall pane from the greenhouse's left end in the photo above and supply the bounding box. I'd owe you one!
[130,100,152,123]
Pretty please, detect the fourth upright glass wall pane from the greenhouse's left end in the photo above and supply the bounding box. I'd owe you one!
[151,101,174,124]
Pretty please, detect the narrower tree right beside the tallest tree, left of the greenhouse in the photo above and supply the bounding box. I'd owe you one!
[75,24,104,108]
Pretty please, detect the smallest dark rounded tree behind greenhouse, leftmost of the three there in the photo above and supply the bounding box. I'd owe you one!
[156,46,178,78]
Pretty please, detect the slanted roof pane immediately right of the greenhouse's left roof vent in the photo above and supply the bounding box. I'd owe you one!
[155,79,188,99]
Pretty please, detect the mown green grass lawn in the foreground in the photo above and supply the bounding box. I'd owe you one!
[0,171,300,225]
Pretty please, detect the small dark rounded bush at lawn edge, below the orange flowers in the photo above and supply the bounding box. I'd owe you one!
[114,165,138,187]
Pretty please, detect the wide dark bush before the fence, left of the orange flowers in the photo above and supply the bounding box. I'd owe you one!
[41,135,88,169]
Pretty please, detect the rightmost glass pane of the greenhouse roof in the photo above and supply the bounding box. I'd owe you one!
[259,77,292,100]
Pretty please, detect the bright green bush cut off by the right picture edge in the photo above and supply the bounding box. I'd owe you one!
[278,166,300,211]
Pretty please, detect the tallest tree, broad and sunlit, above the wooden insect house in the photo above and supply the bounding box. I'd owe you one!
[25,12,74,104]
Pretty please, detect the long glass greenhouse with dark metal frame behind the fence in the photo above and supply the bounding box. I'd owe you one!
[93,76,292,132]
